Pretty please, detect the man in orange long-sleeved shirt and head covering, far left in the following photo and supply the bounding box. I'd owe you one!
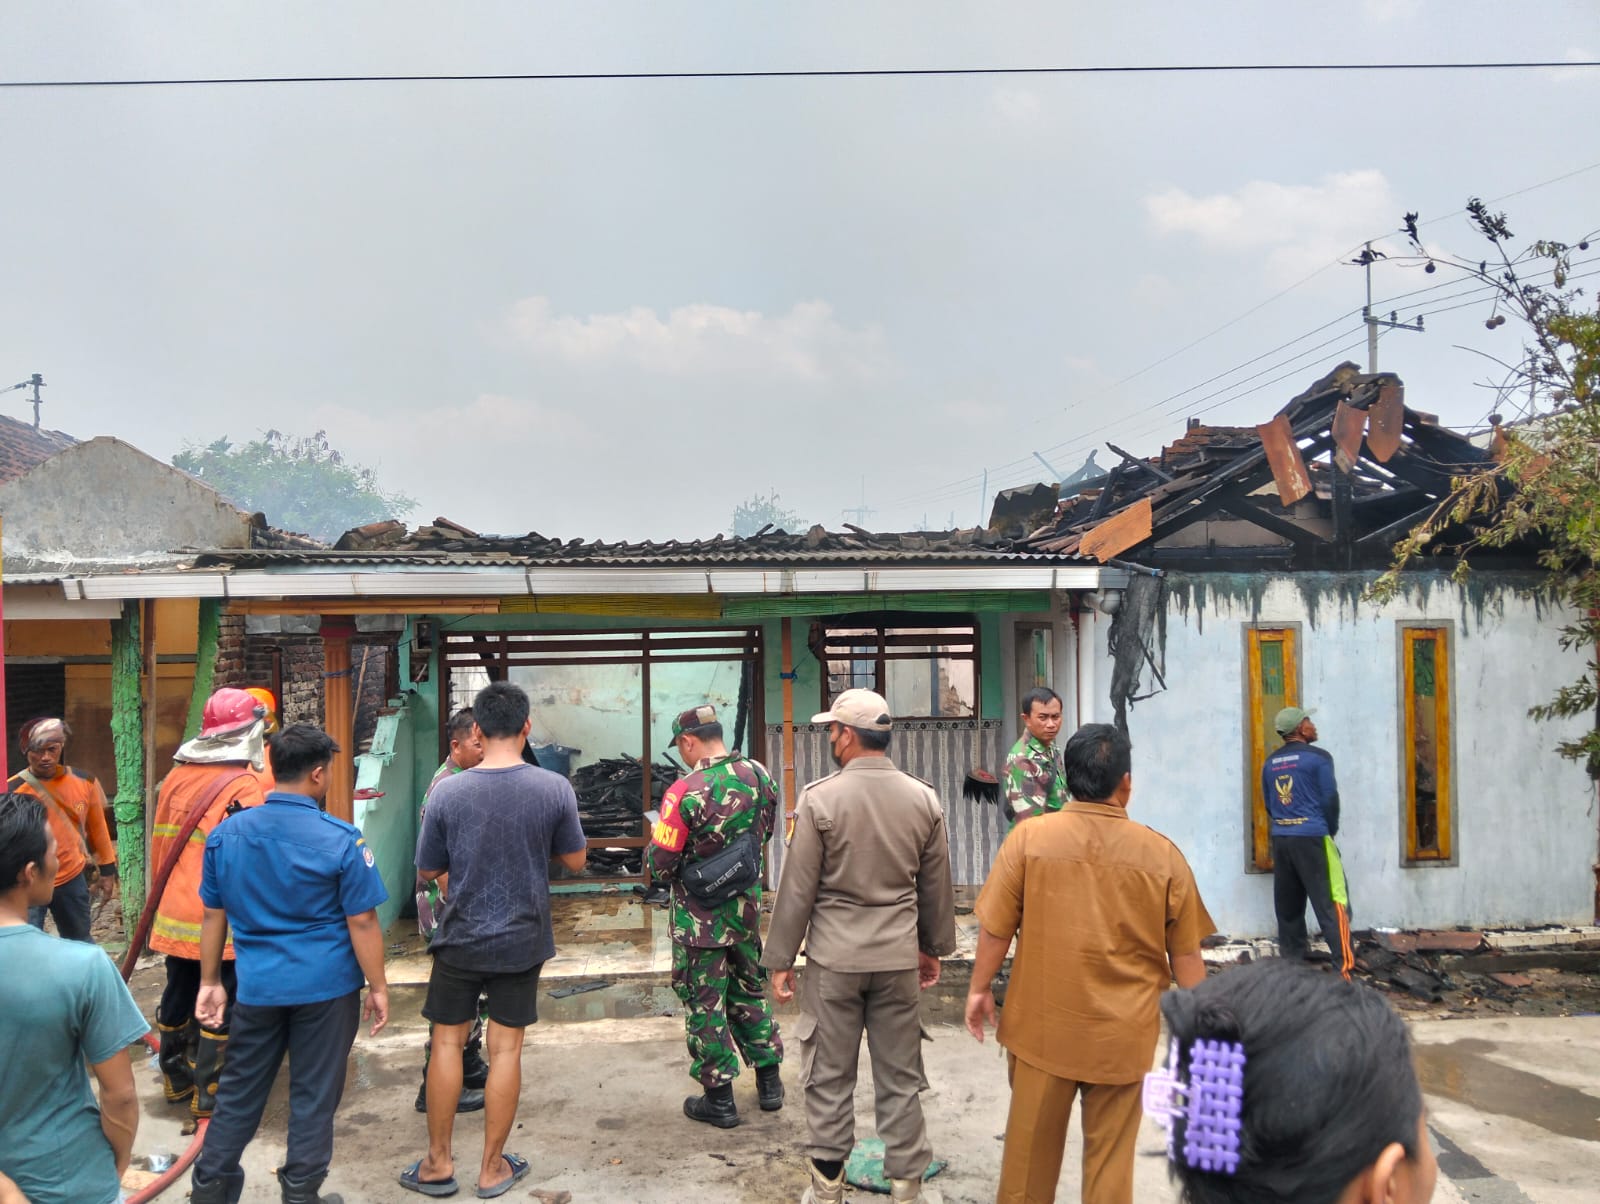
[6,719,117,941]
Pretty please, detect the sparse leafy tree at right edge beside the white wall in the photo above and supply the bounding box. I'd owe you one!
[1370,199,1600,778]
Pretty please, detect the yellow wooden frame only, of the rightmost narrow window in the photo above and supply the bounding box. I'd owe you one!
[1395,620,1461,869]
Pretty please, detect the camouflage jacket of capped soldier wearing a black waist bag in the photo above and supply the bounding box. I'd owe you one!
[645,754,778,948]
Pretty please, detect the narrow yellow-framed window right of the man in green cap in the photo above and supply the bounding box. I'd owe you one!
[1400,624,1454,861]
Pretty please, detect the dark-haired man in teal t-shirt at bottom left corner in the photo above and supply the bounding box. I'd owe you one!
[0,794,150,1204]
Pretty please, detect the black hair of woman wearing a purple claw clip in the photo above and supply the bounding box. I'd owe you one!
[1162,957,1422,1204]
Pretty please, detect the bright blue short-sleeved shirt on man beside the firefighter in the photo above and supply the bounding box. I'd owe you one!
[200,791,389,1007]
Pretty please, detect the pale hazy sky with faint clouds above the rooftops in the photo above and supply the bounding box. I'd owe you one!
[0,0,1600,540]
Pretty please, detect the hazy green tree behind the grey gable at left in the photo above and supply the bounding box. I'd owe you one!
[173,431,416,543]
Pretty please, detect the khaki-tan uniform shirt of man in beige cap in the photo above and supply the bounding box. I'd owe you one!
[762,757,955,973]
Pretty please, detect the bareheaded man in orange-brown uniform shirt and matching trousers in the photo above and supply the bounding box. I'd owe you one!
[966,724,1214,1204]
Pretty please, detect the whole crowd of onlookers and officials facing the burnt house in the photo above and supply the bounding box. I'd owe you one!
[0,682,1435,1204]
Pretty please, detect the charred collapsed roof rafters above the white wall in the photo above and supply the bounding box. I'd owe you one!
[1027,363,1490,568]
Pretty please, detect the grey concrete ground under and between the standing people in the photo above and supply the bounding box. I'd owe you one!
[112,893,1600,1204]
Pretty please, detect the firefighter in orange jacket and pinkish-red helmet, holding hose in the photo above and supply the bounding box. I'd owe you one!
[150,688,266,1119]
